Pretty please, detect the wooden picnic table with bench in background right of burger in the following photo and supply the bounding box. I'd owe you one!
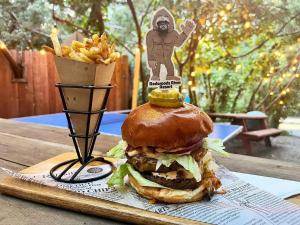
[209,113,282,155]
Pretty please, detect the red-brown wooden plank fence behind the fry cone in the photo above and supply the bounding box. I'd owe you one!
[0,50,131,118]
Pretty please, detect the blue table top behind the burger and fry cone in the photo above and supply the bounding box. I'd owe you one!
[14,112,242,142]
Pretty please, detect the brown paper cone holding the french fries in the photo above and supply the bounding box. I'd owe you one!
[55,56,115,159]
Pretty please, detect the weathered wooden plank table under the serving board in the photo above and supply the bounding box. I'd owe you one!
[0,119,300,225]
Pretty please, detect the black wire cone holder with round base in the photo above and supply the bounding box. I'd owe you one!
[50,83,114,183]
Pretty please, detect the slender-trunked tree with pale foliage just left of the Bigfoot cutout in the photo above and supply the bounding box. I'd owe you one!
[109,0,159,103]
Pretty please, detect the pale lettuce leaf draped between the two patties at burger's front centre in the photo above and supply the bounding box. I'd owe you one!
[156,154,201,182]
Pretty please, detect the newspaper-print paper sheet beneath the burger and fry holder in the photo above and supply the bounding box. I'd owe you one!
[2,165,300,225]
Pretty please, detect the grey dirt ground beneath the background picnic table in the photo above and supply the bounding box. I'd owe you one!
[225,135,300,164]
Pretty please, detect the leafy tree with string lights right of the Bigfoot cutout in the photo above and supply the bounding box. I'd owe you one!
[164,0,300,126]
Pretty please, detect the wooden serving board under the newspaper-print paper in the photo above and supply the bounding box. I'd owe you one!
[0,152,207,225]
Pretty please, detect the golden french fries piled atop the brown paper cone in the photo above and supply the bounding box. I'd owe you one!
[47,30,120,65]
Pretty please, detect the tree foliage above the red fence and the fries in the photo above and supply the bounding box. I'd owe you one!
[0,0,111,49]
